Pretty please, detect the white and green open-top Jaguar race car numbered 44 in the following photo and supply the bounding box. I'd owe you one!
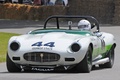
[6,15,116,73]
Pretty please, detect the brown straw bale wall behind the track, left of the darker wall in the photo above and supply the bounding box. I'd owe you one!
[0,3,66,20]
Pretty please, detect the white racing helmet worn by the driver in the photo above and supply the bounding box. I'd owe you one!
[78,20,91,31]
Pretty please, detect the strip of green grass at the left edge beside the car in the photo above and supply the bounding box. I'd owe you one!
[0,32,19,63]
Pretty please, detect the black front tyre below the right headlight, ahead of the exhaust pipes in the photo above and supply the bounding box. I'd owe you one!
[76,46,92,73]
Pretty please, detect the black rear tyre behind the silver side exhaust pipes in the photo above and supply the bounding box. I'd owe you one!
[99,46,115,68]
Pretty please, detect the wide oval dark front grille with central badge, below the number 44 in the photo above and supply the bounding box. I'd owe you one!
[24,52,60,62]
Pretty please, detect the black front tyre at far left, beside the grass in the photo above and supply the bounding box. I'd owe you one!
[6,54,21,72]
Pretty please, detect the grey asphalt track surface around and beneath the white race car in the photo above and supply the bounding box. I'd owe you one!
[0,20,120,80]
